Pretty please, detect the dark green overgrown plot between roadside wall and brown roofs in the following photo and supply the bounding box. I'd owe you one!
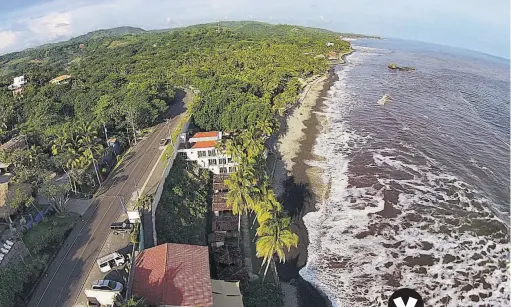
[156,156,211,246]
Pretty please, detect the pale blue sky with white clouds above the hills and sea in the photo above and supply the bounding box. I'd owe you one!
[0,0,510,59]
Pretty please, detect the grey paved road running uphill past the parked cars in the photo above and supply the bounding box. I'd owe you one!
[27,92,190,307]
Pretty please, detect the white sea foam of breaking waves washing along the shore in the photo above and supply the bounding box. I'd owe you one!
[300,53,509,307]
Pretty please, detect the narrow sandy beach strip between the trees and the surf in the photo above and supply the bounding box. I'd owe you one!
[272,64,340,307]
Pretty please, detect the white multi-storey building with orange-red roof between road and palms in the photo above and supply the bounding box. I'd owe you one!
[178,131,236,175]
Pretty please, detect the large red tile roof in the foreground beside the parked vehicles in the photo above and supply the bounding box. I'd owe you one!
[133,243,213,307]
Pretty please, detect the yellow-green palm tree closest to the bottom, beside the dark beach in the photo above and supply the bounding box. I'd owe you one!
[256,213,298,281]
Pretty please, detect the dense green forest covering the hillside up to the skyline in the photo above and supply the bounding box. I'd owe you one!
[0,22,350,190]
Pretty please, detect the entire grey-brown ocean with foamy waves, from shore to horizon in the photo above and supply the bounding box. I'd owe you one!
[300,39,510,307]
